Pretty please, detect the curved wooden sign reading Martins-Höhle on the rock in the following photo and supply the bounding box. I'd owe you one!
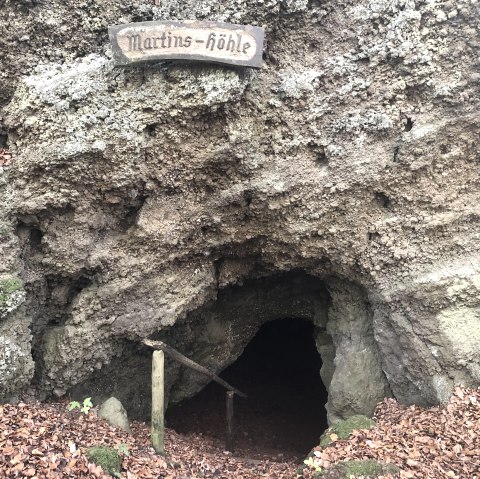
[108,20,264,68]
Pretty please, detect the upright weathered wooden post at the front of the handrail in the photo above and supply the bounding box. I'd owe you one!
[151,351,165,456]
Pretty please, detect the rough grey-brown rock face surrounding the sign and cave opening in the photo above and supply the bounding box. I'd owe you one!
[0,0,480,421]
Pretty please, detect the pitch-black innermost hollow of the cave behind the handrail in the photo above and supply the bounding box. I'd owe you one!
[167,318,327,454]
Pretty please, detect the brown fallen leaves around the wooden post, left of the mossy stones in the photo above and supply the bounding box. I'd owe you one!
[0,403,298,479]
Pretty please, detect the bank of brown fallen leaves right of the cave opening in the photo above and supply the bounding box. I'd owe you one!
[304,387,480,479]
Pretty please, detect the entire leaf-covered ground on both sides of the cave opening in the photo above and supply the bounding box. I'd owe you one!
[0,387,480,479]
